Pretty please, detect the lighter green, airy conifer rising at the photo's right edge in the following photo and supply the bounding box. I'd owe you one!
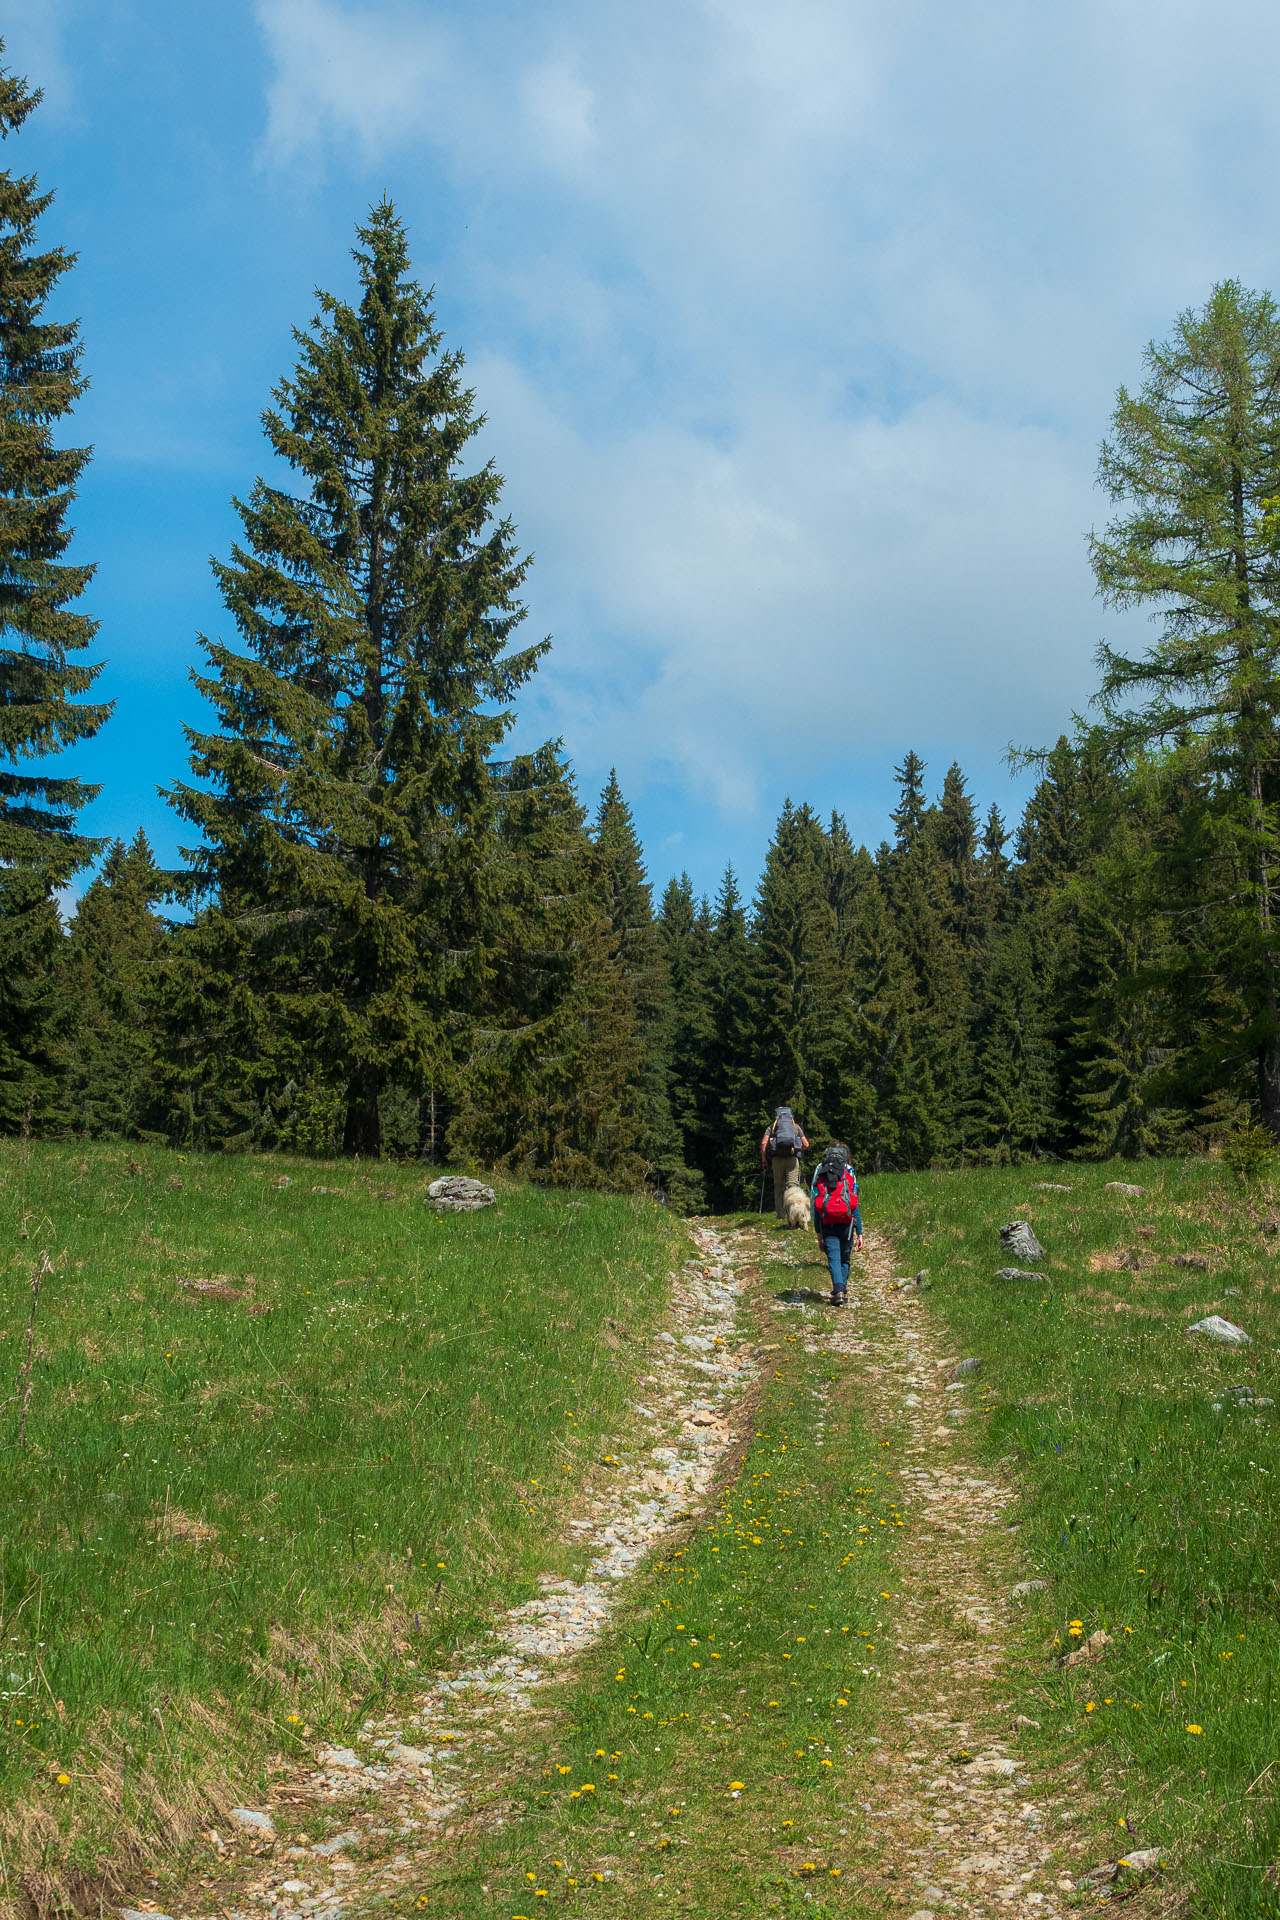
[1092,280,1280,1131]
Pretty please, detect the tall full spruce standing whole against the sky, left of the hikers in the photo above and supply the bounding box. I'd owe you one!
[171,202,543,1152]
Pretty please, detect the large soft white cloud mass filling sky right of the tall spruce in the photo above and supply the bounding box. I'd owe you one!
[257,0,1280,860]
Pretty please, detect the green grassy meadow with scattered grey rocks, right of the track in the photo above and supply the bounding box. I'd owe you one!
[864,1160,1280,1916]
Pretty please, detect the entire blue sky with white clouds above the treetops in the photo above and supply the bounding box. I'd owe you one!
[10,0,1280,889]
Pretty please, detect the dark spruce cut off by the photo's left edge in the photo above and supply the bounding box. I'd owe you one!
[0,42,109,1129]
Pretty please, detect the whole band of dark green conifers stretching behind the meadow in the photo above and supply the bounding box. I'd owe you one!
[0,48,1280,1210]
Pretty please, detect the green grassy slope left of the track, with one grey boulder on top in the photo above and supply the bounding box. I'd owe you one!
[0,1142,674,1895]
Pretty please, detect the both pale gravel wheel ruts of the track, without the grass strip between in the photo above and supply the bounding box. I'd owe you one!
[147,1223,1120,1920]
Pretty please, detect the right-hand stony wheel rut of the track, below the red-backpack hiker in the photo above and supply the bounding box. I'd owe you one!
[759,1236,1105,1920]
